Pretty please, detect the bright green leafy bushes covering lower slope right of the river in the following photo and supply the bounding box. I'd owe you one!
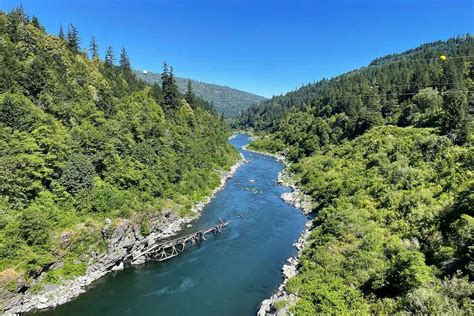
[287,127,474,315]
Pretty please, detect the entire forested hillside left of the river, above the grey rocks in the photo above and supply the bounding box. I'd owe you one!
[0,8,238,305]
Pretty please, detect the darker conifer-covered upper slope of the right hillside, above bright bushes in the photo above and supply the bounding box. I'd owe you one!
[236,35,474,152]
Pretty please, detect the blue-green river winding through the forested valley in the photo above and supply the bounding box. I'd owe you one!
[38,135,306,316]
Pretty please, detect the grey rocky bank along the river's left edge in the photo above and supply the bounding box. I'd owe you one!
[1,156,245,315]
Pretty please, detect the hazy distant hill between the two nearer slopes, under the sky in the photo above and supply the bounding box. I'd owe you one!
[135,71,265,117]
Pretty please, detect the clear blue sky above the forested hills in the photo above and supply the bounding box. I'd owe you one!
[0,0,474,97]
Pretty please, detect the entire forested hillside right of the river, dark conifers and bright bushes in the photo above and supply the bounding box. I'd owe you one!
[243,36,474,315]
